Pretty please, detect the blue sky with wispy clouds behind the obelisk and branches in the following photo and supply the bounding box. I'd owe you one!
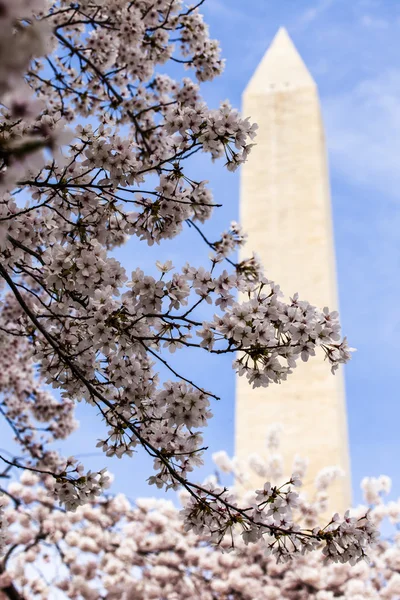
[1,0,400,502]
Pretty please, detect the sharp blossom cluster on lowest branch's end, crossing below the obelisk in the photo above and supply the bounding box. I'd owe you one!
[181,474,378,565]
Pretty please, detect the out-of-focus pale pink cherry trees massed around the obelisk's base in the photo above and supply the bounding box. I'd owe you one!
[0,432,400,600]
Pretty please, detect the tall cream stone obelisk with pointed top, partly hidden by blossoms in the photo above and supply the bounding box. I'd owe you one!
[236,28,351,512]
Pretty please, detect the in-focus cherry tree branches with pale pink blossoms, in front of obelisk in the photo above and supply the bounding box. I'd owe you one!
[0,0,375,562]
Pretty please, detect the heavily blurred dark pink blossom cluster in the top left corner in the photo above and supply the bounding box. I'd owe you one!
[0,0,69,195]
